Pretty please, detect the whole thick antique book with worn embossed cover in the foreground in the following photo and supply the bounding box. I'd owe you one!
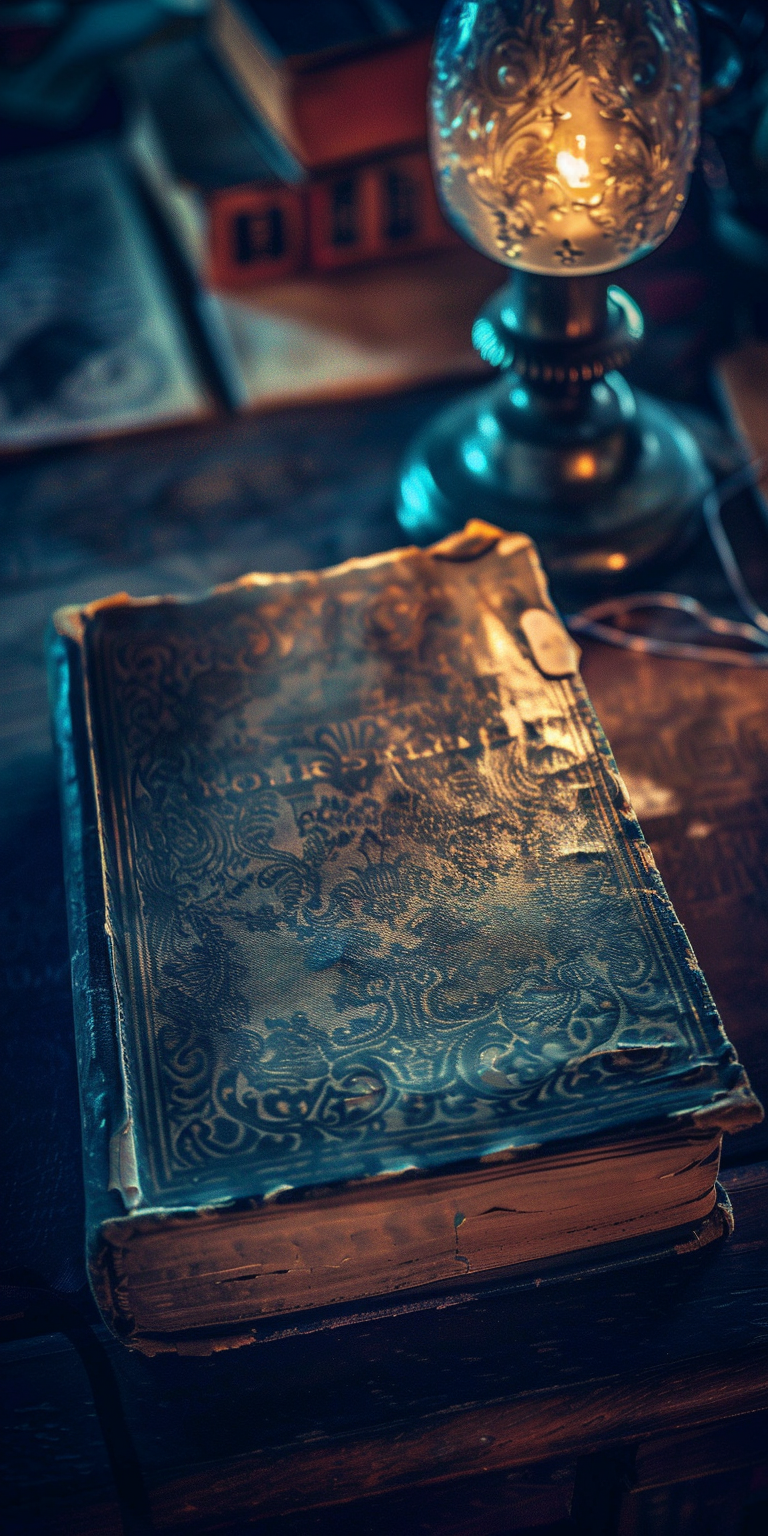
[51,522,762,1350]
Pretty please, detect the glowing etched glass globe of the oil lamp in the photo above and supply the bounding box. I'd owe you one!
[432,0,699,273]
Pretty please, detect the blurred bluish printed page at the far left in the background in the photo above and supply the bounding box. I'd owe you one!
[0,144,210,449]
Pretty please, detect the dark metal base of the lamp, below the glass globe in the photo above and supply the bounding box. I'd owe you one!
[398,276,711,590]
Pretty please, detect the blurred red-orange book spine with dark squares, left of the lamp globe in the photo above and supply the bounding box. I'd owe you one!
[207,149,459,290]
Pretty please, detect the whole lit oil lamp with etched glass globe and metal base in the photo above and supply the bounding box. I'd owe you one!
[398,0,710,584]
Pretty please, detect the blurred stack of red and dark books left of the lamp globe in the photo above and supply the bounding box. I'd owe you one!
[131,0,456,289]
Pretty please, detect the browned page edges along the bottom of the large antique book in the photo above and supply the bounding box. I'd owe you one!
[91,1135,720,1347]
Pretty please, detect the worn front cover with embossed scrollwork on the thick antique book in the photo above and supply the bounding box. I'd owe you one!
[88,547,723,1200]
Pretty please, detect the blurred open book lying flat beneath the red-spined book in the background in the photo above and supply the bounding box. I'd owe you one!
[0,159,498,449]
